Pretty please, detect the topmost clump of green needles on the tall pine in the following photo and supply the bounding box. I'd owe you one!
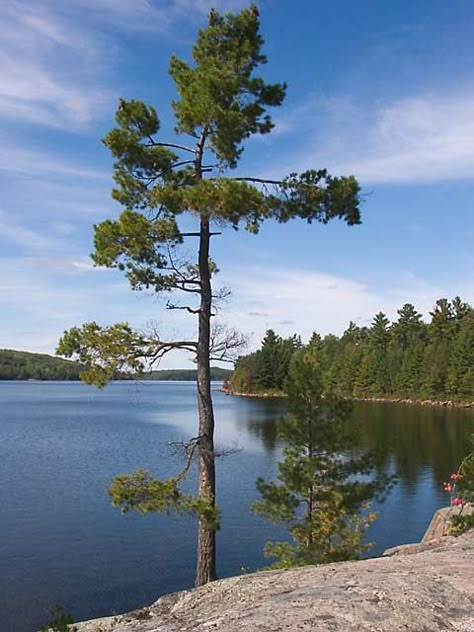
[170,10,286,168]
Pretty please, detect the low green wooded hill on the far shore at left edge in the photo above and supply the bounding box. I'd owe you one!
[0,349,81,380]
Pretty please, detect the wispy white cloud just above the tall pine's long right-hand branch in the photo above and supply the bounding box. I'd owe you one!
[274,89,474,184]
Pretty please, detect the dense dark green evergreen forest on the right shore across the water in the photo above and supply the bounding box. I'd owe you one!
[230,297,474,402]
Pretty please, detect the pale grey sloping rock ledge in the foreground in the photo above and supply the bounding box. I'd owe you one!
[79,530,474,632]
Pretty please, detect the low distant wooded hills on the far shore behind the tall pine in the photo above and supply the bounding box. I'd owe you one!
[0,349,232,381]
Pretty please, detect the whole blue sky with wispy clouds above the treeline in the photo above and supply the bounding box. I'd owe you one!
[0,0,474,366]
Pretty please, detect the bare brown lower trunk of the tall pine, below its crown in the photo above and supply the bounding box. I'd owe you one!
[196,218,216,586]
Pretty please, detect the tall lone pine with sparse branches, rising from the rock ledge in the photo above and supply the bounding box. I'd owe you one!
[58,9,360,584]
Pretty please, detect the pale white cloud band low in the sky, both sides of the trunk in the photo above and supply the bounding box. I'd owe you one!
[0,255,474,367]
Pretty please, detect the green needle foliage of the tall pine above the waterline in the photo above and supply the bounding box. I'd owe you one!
[58,3,360,388]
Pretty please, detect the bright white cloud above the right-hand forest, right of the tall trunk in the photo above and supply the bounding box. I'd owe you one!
[223,266,474,346]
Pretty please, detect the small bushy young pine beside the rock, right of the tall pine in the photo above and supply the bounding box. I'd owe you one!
[253,350,390,568]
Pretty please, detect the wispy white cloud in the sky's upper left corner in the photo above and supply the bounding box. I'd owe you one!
[0,0,112,129]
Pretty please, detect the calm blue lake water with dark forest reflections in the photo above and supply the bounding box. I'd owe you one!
[0,382,474,632]
